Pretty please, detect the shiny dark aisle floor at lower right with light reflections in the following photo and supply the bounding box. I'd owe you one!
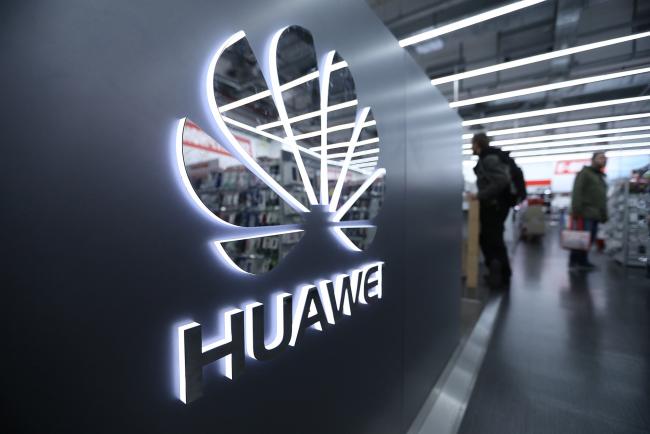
[459,232,650,434]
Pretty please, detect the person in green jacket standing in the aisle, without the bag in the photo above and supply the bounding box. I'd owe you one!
[569,152,607,269]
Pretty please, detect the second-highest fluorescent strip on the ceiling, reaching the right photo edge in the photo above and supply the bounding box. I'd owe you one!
[431,32,650,86]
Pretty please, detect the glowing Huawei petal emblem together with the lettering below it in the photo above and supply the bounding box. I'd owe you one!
[176,26,386,403]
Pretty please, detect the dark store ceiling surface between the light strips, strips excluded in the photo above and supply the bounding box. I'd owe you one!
[367,0,650,156]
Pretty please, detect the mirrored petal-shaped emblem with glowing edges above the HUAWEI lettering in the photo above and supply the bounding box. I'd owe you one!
[176,26,385,274]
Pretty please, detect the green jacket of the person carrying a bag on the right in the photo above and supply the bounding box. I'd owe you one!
[571,166,607,222]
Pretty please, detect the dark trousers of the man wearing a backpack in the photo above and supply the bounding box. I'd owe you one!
[479,203,512,279]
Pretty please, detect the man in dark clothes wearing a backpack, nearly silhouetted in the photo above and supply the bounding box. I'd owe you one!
[472,133,526,289]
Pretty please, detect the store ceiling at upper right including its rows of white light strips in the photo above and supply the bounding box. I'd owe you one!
[367,0,650,162]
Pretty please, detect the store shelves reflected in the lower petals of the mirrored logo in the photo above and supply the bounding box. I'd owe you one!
[189,152,384,274]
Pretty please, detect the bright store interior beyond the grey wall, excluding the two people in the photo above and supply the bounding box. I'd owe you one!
[368,0,650,433]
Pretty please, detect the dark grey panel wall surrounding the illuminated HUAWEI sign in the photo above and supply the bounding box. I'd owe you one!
[0,0,461,434]
